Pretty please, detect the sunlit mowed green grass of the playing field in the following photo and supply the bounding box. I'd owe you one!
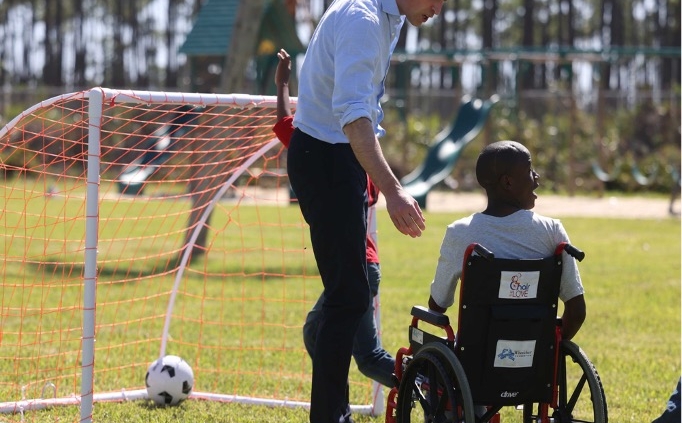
[0,193,680,423]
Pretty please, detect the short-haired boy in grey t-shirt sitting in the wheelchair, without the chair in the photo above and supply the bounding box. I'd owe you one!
[429,141,585,340]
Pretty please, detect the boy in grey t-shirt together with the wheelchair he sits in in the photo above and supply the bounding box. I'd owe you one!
[386,141,607,423]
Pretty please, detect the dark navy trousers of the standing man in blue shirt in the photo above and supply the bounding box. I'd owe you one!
[287,129,371,423]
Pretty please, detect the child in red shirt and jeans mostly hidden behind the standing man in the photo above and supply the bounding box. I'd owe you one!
[272,49,395,387]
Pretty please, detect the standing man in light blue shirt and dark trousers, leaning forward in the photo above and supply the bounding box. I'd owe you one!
[287,0,444,423]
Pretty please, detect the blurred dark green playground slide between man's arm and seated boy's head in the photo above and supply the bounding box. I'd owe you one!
[400,95,499,209]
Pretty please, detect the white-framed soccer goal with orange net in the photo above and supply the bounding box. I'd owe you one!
[0,88,384,422]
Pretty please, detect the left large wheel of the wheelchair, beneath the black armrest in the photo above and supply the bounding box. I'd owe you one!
[396,342,475,423]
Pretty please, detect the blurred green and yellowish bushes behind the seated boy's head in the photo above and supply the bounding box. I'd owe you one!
[382,92,680,194]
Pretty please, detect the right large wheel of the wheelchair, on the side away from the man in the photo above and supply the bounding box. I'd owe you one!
[523,341,608,423]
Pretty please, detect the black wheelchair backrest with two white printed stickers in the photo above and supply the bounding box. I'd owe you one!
[455,248,562,406]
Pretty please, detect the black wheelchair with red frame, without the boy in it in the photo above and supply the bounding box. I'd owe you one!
[385,243,608,423]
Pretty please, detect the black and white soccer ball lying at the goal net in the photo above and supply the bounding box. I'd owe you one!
[144,355,194,405]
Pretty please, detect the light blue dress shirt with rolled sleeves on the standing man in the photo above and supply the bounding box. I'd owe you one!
[294,0,405,144]
